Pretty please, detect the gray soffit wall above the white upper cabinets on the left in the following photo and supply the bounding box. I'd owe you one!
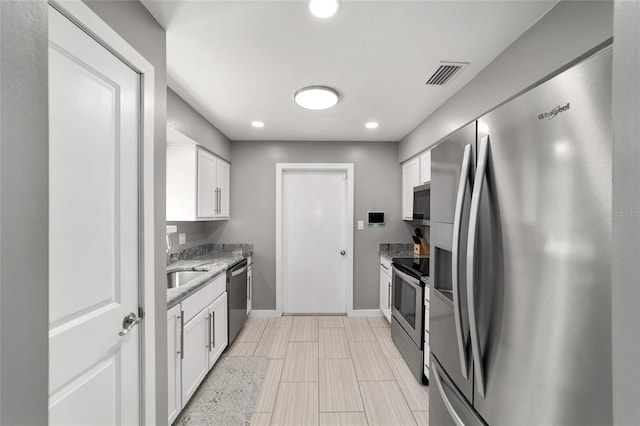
[167,88,231,161]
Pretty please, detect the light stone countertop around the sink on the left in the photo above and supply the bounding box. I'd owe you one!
[167,251,251,309]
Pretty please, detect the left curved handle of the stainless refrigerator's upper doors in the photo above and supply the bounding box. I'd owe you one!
[451,144,471,379]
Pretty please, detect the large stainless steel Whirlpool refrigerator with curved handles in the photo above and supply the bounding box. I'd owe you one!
[429,46,613,426]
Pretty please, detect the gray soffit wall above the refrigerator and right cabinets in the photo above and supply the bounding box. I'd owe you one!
[399,0,613,162]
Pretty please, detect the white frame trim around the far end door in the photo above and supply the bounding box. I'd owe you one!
[276,163,355,316]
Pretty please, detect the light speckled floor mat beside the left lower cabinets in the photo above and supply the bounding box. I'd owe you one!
[174,356,267,426]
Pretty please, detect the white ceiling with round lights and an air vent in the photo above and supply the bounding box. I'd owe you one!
[142,0,557,141]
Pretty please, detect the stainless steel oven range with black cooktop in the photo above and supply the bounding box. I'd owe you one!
[391,258,429,383]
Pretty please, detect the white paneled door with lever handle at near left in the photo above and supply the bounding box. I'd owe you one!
[48,7,140,425]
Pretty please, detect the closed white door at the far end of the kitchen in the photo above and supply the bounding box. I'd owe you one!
[282,170,348,314]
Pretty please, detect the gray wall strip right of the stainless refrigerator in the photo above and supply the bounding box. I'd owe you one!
[612,0,640,425]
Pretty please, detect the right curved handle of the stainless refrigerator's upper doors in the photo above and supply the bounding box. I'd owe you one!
[467,136,489,398]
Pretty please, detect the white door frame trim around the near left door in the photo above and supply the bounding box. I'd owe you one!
[48,0,160,424]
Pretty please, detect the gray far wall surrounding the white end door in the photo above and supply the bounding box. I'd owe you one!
[206,141,411,310]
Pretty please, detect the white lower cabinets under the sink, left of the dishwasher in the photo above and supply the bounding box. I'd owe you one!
[167,274,228,424]
